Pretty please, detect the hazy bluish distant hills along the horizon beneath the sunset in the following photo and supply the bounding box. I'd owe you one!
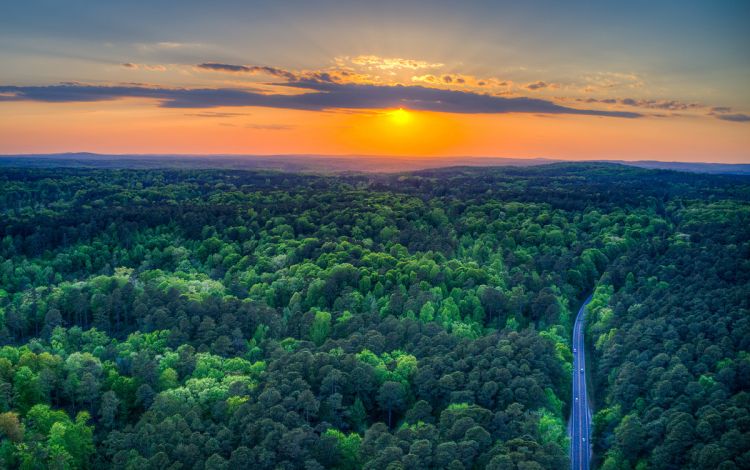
[0,152,750,175]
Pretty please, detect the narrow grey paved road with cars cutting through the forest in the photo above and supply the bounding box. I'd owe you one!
[568,296,591,470]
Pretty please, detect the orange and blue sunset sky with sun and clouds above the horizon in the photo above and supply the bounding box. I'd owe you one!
[0,0,750,163]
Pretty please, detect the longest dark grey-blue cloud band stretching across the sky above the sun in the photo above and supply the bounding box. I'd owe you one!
[0,80,641,118]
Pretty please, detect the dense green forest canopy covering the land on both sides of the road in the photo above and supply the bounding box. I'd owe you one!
[0,165,750,469]
